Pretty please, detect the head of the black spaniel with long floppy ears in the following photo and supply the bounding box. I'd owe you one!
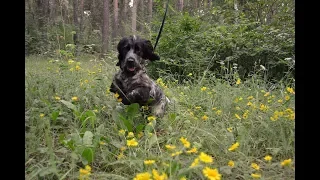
[116,36,160,74]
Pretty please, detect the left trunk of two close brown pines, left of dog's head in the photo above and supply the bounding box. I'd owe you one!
[102,0,109,54]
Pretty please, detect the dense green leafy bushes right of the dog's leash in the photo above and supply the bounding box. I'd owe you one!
[151,7,294,80]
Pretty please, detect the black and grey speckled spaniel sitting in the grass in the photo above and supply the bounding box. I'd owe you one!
[110,35,169,117]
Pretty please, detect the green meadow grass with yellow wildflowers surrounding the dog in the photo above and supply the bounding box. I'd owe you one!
[25,55,295,180]
